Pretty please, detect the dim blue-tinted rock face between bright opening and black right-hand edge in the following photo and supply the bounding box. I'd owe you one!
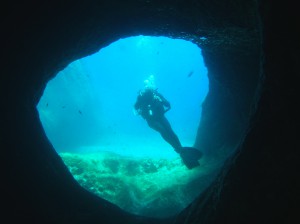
[195,48,261,157]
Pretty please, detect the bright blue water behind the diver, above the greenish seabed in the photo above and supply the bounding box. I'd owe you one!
[37,36,208,157]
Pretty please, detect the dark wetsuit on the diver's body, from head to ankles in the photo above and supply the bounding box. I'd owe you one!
[134,89,182,152]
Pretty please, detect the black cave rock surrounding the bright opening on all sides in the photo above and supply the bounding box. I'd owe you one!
[0,0,300,223]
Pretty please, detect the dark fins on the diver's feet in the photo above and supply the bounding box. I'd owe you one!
[180,147,203,169]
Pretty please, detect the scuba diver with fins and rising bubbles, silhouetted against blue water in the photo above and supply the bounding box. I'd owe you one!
[134,75,202,169]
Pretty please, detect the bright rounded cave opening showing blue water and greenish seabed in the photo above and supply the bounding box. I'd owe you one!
[37,36,215,217]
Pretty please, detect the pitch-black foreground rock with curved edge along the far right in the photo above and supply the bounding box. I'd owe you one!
[175,1,300,224]
